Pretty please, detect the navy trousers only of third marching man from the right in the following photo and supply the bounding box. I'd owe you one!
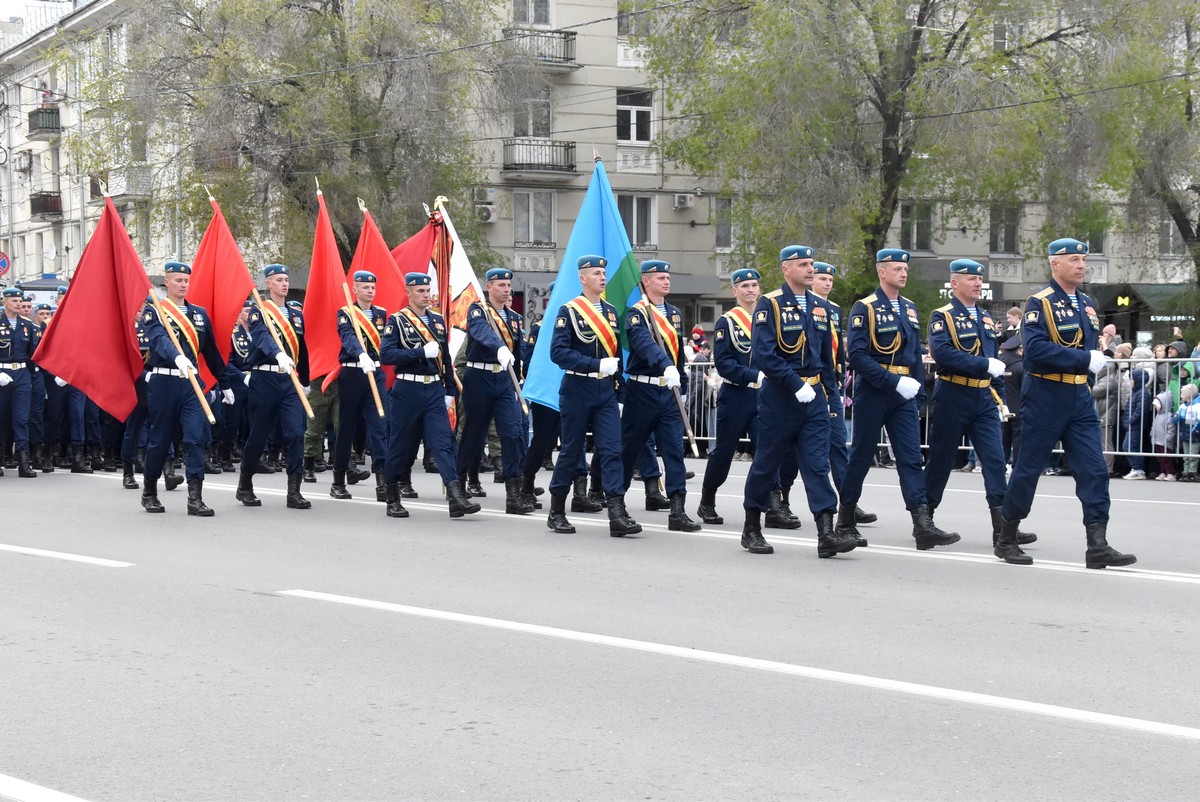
[838,382,926,510]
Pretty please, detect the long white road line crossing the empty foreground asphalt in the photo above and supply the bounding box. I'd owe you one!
[278,589,1200,741]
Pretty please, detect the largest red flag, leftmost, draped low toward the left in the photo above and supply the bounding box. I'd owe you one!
[34,198,150,420]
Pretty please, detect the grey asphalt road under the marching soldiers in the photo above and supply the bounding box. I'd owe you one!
[0,462,1200,801]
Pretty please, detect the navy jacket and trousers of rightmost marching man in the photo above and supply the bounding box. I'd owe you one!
[1003,281,1109,526]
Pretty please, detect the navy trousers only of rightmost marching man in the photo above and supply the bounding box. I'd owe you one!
[1003,375,1109,526]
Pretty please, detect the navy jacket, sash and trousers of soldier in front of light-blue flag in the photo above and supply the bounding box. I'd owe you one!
[550,295,625,498]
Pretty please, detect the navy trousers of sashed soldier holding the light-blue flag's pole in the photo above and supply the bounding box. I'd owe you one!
[619,382,688,496]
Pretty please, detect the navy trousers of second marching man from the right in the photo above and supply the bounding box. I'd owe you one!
[925,379,1004,509]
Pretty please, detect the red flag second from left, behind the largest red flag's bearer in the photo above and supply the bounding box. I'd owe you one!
[187,198,254,387]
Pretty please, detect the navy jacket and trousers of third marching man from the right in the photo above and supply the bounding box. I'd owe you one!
[839,288,926,510]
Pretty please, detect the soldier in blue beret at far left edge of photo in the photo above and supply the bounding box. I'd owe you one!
[0,287,38,479]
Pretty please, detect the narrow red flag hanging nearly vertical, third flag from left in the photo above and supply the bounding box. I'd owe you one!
[304,190,346,387]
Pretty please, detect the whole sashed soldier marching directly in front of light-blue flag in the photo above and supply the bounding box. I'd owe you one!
[546,255,642,538]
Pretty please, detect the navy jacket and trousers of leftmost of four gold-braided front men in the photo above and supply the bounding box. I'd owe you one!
[743,283,838,517]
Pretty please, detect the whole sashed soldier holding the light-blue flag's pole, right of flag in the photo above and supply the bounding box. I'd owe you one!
[620,259,700,532]
